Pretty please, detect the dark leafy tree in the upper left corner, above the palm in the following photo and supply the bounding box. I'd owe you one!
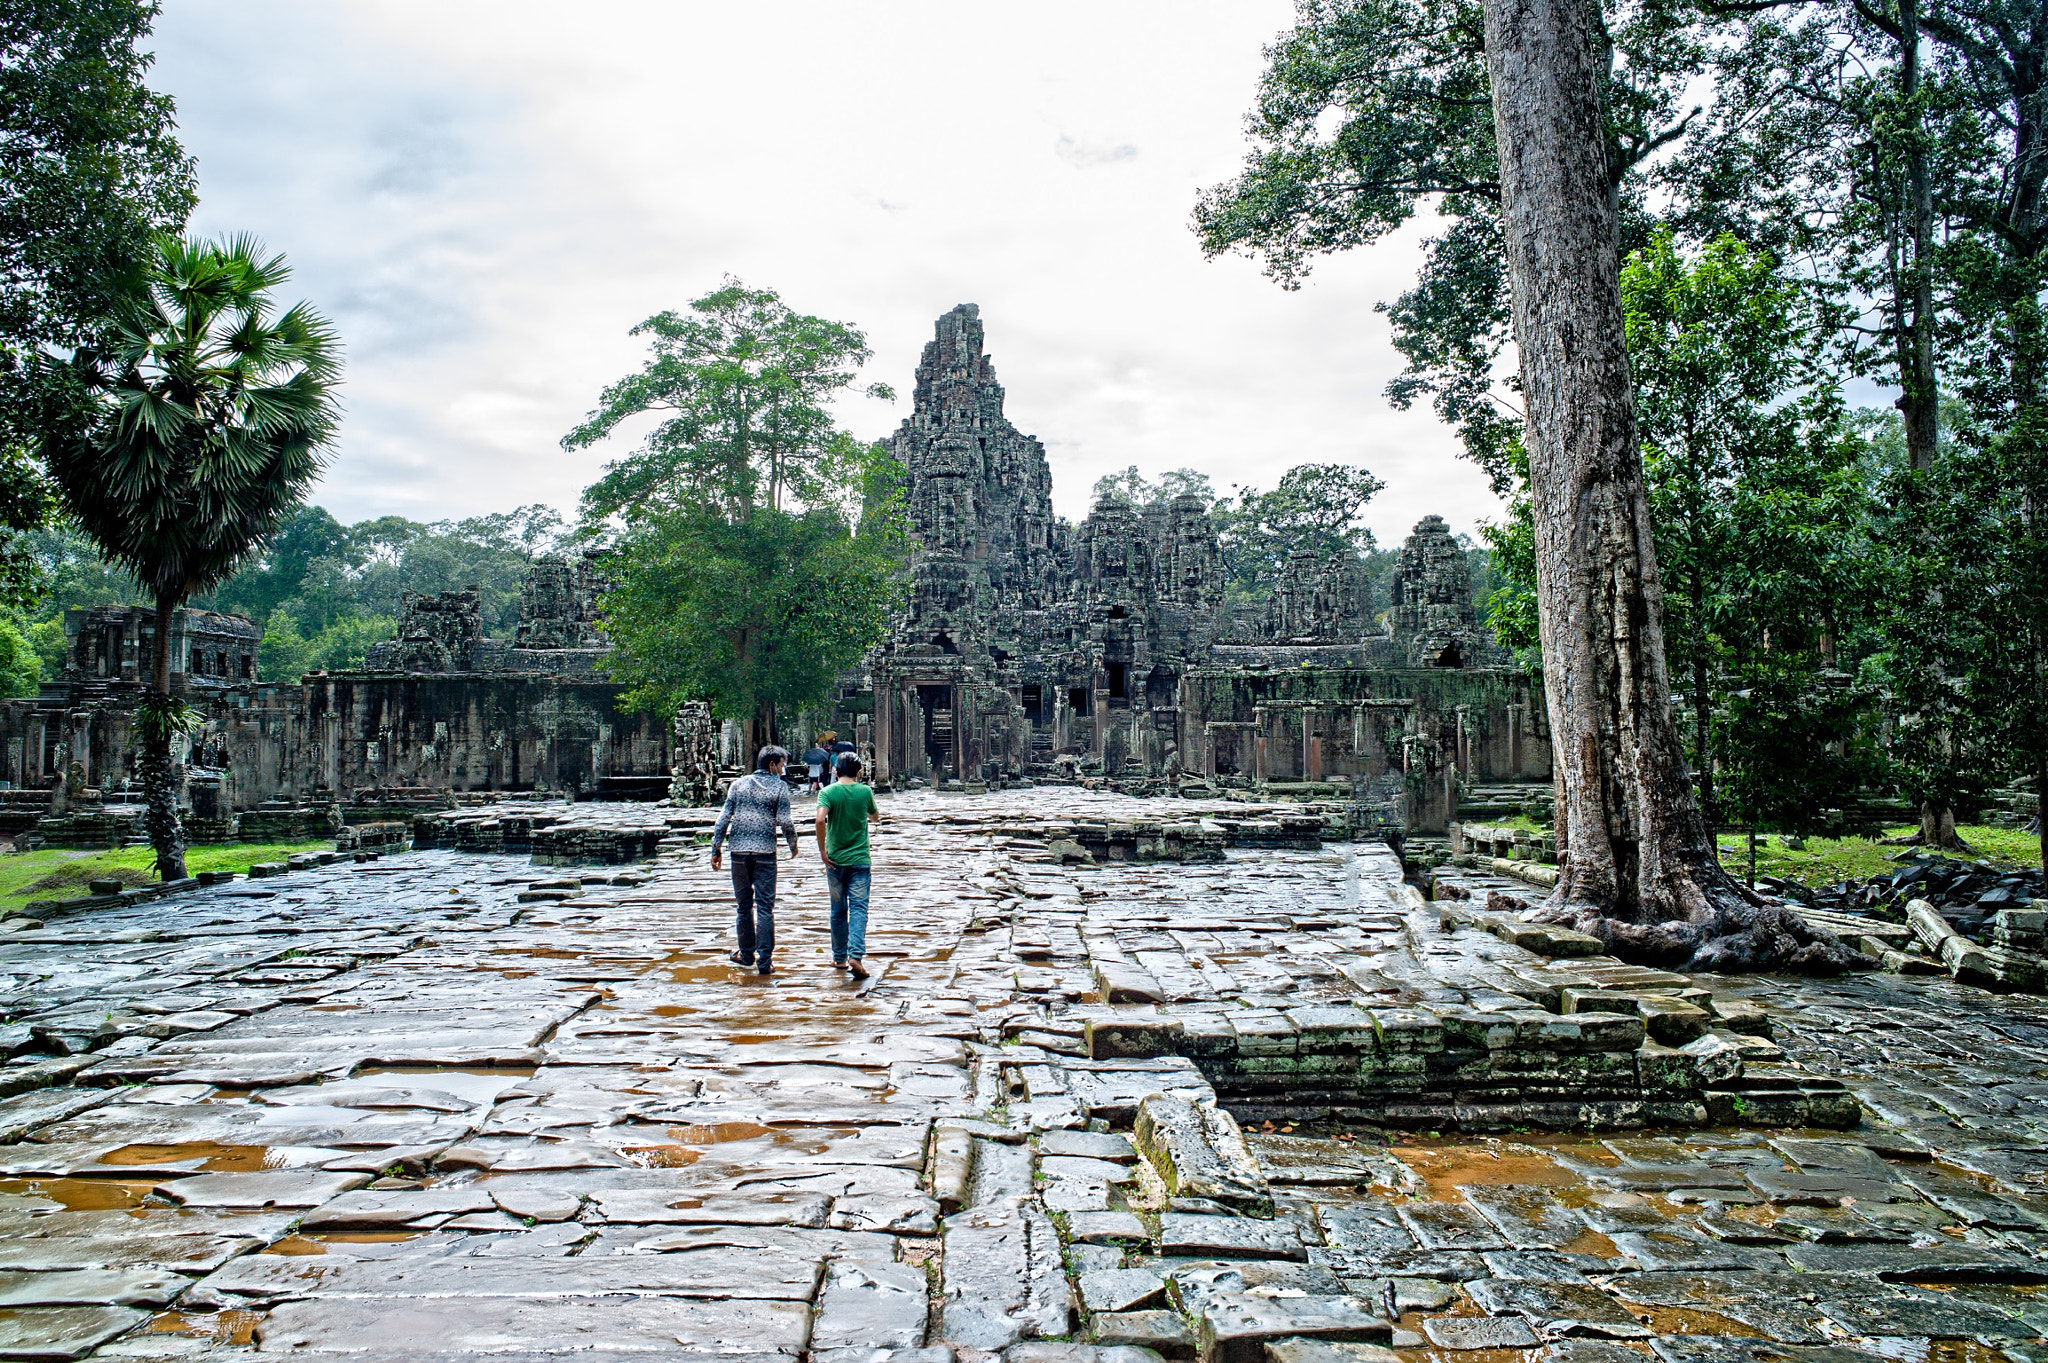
[0,0,193,606]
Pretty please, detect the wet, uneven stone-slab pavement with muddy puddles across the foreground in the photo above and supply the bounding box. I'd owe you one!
[0,790,2048,1363]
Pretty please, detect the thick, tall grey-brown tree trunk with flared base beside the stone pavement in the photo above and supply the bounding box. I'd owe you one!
[1485,0,1862,970]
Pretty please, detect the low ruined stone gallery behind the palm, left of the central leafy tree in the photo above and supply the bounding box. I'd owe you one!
[0,559,670,817]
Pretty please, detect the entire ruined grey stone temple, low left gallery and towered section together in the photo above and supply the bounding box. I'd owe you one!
[0,305,1550,845]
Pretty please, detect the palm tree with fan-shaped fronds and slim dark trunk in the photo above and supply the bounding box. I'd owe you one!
[43,235,340,880]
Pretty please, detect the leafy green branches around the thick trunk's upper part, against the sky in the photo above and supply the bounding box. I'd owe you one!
[1194,0,1704,482]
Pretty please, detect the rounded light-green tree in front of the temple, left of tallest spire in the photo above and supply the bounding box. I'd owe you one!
[563,280,905,747]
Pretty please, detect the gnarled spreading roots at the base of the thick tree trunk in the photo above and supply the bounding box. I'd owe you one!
[1515,894,1878,976]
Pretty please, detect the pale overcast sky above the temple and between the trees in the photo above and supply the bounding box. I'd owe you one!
[154,0,1497,544]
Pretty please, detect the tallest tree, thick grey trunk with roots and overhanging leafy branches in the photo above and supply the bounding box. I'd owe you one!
[1196,0,1849,966]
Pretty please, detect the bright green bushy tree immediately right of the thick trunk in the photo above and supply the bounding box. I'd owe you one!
[1622,233,1870,831]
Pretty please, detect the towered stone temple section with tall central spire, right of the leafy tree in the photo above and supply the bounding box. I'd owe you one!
[842,305,1550,829]
